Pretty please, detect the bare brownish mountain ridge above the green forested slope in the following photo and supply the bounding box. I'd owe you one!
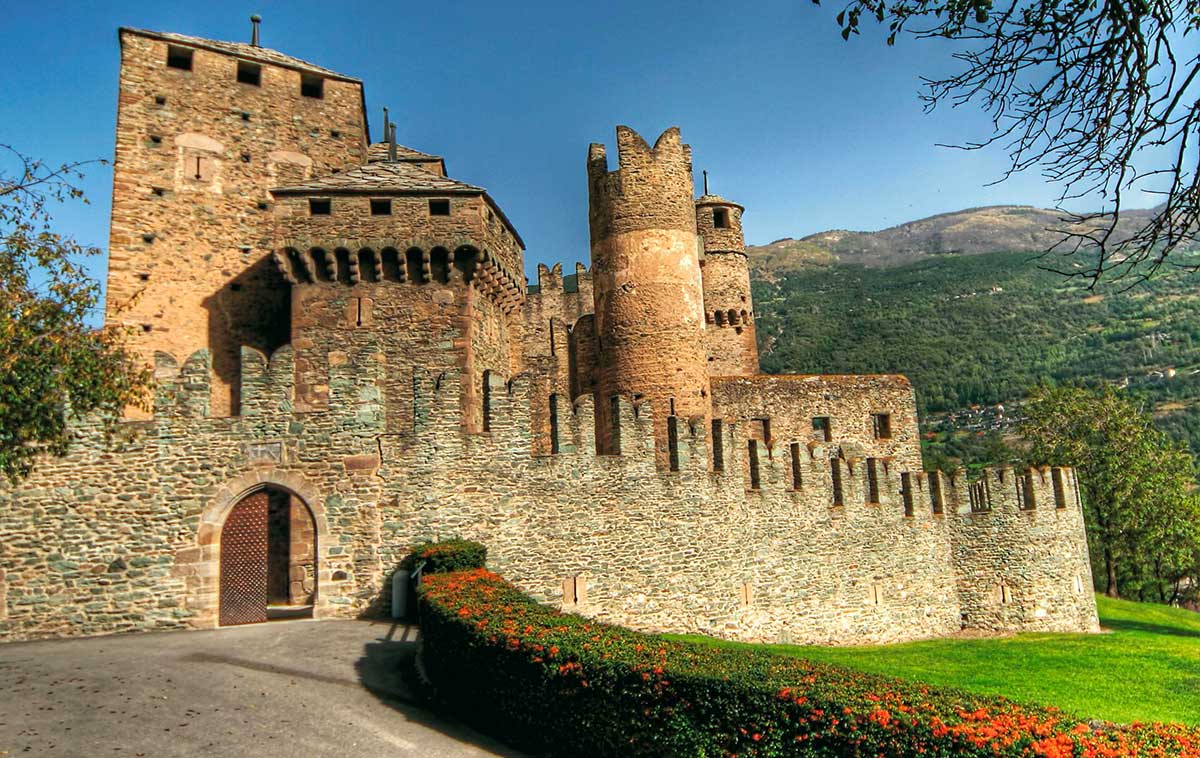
[748,205,1153,277]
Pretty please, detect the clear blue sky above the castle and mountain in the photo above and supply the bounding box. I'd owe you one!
[0,0,1152,286]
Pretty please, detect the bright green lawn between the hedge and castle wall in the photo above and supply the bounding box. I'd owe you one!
[685,597,1200,724]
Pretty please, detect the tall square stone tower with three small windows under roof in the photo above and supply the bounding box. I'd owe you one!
[106,29,370,415]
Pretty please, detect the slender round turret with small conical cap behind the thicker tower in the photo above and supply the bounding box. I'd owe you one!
[696,194,758,377]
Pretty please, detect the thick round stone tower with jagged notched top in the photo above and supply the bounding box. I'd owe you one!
[588,126,712,463]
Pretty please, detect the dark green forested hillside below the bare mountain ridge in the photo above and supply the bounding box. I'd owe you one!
[752,252,1200,462]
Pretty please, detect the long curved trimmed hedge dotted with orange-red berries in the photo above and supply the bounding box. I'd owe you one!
[420,569,1200,758]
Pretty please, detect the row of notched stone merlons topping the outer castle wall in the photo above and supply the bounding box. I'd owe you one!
[136,345,1079,522]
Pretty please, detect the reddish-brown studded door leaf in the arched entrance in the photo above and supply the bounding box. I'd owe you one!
[221,491,270,626]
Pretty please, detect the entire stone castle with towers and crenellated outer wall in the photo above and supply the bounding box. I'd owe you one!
[0,26,1098,644]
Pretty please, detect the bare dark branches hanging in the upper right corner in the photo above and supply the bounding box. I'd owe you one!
[812,0,1200,287]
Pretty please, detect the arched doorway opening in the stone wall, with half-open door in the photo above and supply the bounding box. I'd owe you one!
[218,487,317,626]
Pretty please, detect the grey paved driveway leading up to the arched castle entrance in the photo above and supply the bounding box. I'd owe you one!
[0,621,517,758]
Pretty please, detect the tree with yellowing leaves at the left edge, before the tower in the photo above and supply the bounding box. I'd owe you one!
[0,145,149,481]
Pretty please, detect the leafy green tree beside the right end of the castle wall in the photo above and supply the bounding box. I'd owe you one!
[1021,387,1200,602]
